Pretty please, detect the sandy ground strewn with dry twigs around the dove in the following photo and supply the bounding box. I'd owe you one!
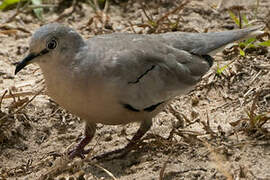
[0,0,270,180]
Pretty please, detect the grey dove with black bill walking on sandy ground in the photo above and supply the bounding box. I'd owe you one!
[15,23,263,159]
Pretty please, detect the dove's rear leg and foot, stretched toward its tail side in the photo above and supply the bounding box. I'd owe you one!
[94,119,152,159]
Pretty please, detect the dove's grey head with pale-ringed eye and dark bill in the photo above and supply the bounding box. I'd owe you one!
[15,23,84,74]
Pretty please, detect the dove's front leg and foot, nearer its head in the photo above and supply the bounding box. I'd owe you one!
[68,123,96,159]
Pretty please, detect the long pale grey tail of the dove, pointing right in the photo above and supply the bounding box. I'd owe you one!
[160,26,264,55]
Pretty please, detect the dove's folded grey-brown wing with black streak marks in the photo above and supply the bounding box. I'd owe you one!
[100,38,211,110]
